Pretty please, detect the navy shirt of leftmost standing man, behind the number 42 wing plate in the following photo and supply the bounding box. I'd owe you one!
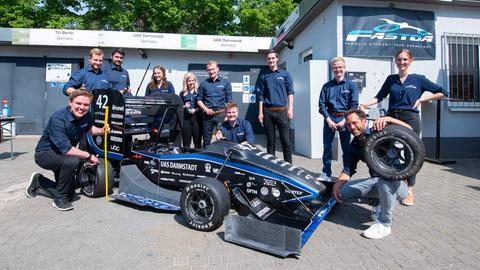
[63,66,110,95]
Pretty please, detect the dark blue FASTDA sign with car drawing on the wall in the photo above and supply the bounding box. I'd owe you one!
[343,6,435,59]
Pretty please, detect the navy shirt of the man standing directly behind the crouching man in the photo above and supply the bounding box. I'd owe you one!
[197,77,233,110]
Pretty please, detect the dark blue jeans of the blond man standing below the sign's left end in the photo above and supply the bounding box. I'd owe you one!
[322,116,351,177]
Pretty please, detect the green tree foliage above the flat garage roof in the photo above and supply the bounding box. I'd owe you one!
[0,0,299,36]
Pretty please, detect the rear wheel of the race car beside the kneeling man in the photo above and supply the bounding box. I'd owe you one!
[78,159,115,198]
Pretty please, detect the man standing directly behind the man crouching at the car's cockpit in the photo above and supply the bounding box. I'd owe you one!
[197,61,232,146]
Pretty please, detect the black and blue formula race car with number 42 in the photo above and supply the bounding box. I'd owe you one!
[79,90,426,257]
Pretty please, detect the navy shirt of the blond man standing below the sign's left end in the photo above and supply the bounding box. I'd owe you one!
[318,78,358,119]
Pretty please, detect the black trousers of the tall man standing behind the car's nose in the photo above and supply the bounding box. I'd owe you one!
[263,110,292,163]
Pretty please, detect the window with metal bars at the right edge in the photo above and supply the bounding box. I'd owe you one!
[446,34,480,107]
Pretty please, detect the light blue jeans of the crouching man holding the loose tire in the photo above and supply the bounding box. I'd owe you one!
[341,177,407,226]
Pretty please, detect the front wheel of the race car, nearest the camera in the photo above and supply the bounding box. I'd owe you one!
[180,177,230,231]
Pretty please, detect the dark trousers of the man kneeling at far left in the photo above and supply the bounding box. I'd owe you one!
[35,149,80,199]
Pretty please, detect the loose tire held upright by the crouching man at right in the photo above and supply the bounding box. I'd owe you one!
[363,125,425,180]
